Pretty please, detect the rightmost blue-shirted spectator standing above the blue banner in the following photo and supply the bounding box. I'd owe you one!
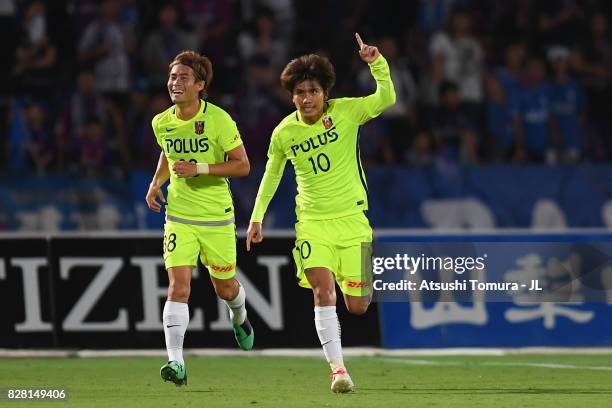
[547,46,586,163]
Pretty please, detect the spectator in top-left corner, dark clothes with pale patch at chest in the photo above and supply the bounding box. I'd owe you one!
[13,0,57,96]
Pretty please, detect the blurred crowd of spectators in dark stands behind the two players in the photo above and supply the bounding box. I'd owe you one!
[0,0,612,175]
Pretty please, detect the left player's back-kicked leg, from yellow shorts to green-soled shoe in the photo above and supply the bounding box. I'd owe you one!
[200,224,255,350]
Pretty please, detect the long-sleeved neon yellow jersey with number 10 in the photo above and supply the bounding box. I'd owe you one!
[251,55,395,222]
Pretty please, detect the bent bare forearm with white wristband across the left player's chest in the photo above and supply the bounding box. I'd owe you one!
[172,145,251,178]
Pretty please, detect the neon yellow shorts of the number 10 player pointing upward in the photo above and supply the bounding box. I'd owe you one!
[293,213,372,296]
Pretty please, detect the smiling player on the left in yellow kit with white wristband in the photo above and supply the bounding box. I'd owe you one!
[146,51,254,386]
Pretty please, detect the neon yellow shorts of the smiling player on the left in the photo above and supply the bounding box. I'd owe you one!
[164,220,236,279]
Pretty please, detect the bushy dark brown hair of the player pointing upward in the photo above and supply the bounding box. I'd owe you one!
[280,54,336,96]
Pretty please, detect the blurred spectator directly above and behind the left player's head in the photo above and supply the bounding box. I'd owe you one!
[142,3,197,90]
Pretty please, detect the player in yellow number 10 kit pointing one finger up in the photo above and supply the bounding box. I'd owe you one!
[246,33,395,393]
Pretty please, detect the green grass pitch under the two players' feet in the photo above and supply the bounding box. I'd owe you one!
[0,353,612,408]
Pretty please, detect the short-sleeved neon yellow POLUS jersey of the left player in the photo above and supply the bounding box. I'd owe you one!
[152,100,242,221]
